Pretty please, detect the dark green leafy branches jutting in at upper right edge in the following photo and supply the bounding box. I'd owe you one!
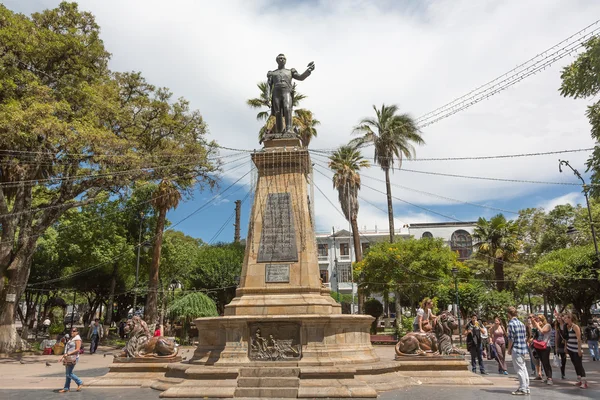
[560,36,600,197]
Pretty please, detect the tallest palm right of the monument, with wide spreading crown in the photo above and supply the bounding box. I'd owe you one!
[350,104,425,243]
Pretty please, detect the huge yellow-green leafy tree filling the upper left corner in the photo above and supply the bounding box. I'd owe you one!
[0,2,216,353]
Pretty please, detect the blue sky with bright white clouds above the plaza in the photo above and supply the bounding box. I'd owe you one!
[3,0,600,241]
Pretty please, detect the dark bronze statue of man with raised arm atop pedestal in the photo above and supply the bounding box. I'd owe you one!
[267,54,315,135]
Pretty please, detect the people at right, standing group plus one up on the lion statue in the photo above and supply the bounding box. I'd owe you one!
[413,298,600,395]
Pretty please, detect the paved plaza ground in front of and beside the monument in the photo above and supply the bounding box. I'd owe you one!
[0,346,600,400]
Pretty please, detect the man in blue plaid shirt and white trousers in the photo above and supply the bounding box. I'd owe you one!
[507,307,530,396]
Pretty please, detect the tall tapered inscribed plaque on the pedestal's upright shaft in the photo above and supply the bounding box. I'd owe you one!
[256,193,298,263]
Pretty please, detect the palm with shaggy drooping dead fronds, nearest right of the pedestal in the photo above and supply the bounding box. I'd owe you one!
[329,145,371,262]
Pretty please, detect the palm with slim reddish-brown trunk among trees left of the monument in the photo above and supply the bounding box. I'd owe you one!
[144,179,181,324]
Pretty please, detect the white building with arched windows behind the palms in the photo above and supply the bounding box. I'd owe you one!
[316,221,476,308]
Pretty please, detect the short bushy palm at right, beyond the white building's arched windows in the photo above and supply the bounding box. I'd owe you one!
[473,214,519,291]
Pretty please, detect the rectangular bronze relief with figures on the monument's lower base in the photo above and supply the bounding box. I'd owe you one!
[248,322,302,361]
